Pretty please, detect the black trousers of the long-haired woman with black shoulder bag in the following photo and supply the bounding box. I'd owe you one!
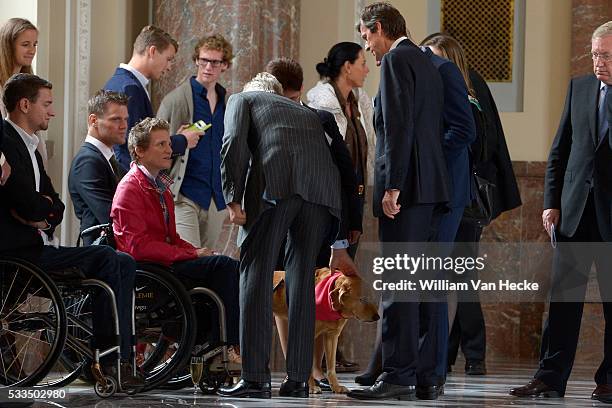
[448,220,486,364]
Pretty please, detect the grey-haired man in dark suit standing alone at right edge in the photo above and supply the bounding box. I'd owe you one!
[510,21,612,403]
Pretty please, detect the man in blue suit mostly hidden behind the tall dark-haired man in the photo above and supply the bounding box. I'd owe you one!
[421,43,476,385]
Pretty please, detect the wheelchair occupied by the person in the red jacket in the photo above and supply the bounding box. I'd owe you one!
[77,224,240,394]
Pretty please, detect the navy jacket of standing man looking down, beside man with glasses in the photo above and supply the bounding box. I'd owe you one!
[104,68,187,171]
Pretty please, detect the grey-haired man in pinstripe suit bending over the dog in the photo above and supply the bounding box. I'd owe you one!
[218,73,341,398]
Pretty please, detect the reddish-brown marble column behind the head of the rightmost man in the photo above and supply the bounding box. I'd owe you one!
[571,0,612,76]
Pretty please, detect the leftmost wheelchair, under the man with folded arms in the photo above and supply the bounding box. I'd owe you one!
[0,257,134,398]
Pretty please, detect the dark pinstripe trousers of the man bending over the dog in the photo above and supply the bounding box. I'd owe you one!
[240,195,332,382]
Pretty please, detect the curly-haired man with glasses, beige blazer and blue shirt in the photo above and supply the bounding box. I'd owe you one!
[157,34,233,248]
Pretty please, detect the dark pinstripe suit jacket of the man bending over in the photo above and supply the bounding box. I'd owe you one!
[221,92,342,246]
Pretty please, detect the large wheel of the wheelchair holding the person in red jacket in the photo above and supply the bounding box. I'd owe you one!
[135,265,196,391]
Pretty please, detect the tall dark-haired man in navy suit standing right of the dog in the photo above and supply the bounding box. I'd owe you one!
[348,3,449,399]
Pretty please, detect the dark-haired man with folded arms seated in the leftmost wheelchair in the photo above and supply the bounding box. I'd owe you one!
[0,74,142,387]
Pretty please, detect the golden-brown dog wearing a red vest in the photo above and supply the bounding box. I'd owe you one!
[272,268,379,394]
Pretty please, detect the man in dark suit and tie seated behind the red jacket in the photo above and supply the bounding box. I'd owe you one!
[68,91,128,245]
